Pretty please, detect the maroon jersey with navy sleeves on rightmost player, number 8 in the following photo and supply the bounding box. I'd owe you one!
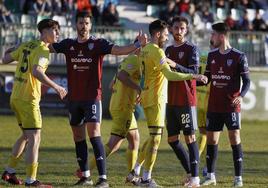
[205,48,249,113]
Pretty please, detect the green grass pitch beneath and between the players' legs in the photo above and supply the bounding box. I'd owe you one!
[0,116,268,188]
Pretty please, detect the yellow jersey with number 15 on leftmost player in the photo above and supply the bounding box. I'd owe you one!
[11,40,49,103]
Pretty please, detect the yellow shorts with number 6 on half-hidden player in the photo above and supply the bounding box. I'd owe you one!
[110,110,138,138]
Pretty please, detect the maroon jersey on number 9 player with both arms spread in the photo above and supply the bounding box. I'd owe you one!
[53,36,113,101]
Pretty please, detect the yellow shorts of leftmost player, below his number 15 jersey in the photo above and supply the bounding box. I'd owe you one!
[10,99,42,130]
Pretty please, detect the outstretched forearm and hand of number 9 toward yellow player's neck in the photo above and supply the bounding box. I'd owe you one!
[111,31,148,55]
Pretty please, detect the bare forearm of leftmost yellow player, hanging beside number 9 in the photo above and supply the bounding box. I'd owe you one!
[32,65,67,99]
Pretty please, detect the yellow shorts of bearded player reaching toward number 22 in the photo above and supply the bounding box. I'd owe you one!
[144,103,166,128]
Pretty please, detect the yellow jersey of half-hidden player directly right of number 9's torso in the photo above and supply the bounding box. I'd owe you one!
[110,55,141,110]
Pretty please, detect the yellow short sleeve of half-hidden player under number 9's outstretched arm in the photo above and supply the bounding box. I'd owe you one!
[121,55,139,75]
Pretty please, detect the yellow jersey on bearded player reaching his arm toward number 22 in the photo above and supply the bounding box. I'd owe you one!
[139,43,167,107]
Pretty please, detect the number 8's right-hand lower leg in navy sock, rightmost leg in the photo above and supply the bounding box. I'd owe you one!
[228,129,243,187]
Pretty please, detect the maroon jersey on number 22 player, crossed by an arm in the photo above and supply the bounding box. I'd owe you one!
[166,41,199,106]
